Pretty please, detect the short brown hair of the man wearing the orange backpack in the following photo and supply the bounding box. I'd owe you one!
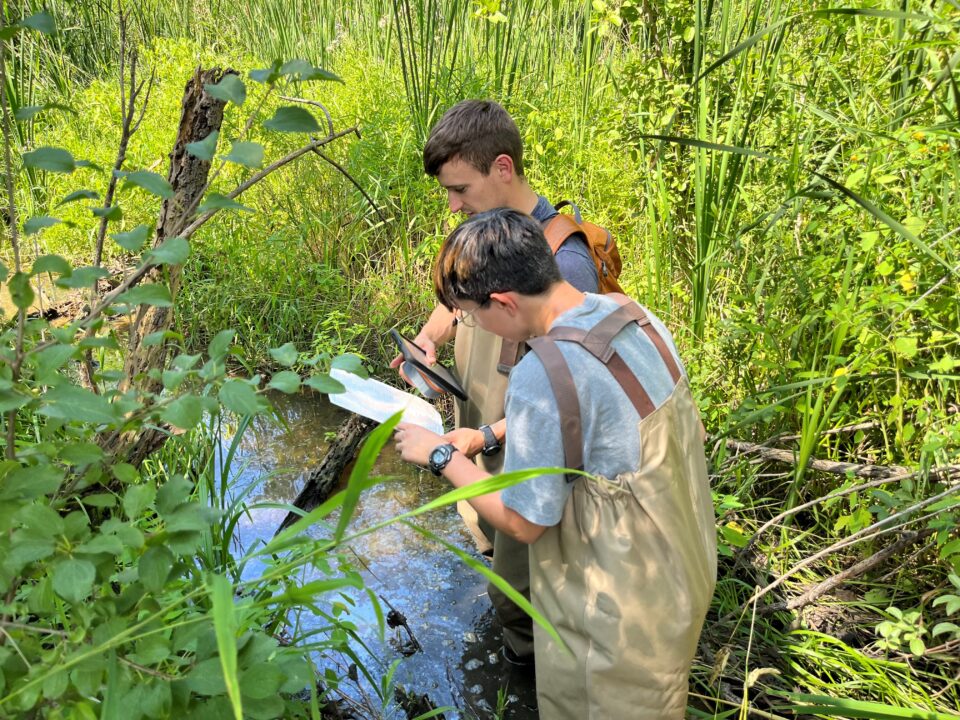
[423,100,523,177]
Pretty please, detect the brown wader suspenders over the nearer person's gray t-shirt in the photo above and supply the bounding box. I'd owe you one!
[524,294,681,482]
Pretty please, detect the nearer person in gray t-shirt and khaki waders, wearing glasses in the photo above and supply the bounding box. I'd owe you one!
[396,209,716,720]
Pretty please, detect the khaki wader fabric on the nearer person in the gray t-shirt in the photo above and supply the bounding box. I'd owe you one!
[530,378,717,720]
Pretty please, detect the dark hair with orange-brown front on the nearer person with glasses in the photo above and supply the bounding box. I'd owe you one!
[433,208,562,310]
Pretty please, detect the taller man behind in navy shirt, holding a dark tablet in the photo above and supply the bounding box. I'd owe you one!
[391,100,598,662]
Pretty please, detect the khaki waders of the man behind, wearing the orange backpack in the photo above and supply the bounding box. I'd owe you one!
[454,325,533,657]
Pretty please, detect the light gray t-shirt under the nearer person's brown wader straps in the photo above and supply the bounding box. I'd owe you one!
[501,294,683,526]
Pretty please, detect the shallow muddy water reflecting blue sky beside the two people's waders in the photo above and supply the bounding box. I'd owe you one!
[224,395,537,720]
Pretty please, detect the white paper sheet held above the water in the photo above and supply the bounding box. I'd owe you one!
[330,368,444,435]
